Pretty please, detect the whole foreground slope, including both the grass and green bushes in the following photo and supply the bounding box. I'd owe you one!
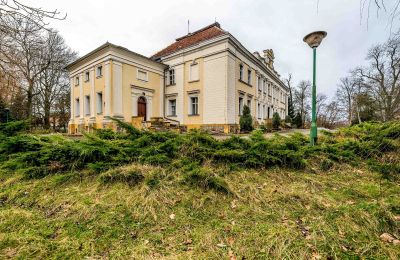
[0,120,400,259]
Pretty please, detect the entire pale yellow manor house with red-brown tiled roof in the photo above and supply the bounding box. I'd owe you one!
[67,23,288,133]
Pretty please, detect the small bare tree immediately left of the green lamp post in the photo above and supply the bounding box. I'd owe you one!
[293,80,311,127]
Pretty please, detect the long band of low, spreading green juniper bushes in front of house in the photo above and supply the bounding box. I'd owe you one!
[0,117,400,184]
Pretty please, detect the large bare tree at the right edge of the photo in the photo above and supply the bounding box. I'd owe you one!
[355,33,400,121]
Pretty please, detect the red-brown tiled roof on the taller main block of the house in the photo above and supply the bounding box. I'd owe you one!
[151,22,227,59]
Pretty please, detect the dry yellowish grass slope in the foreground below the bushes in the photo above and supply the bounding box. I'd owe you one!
[0,165,400,259]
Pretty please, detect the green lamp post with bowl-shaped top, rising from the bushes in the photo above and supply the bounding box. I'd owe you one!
[303,31,327,146]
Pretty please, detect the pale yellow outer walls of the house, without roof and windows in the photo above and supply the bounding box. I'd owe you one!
[67,34,286,134]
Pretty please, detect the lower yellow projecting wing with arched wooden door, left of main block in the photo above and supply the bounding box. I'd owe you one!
[67,43,166,133]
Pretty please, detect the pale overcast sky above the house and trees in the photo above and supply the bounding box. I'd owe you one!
[27,0,398,96]
